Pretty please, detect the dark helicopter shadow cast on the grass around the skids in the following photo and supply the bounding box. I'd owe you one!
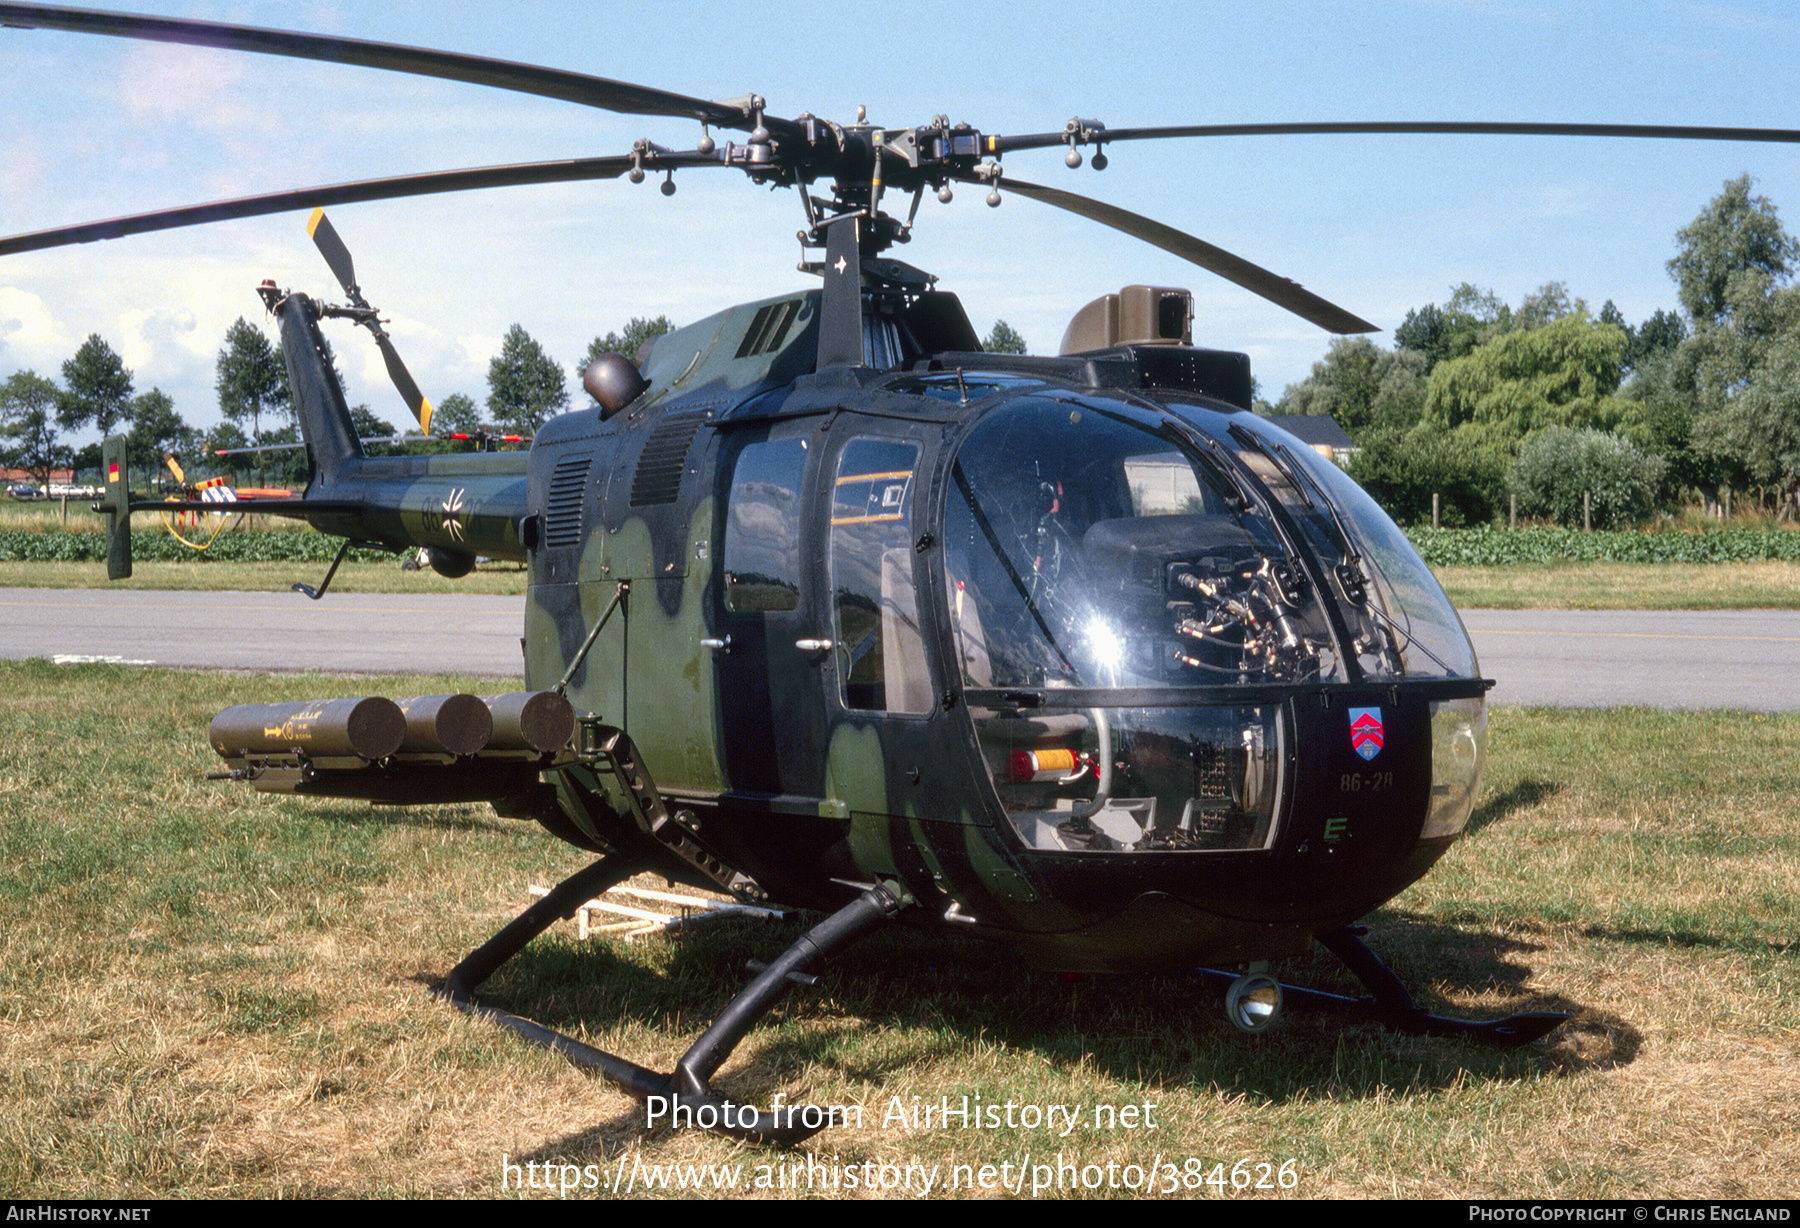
[417,885,1642,1156]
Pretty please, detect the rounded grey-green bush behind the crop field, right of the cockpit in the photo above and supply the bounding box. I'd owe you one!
[1507,427,1667,529]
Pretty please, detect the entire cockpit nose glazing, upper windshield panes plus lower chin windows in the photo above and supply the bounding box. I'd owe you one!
[943,391,1485,853]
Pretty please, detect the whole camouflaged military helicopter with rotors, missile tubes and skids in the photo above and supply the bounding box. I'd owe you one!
[0,4,1800,1143]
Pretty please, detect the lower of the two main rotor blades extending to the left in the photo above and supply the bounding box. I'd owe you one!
[0,153,722,256]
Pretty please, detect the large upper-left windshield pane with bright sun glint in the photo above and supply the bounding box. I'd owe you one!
[945,398,1343,688]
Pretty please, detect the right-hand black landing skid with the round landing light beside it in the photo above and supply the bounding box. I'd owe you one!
[1201,926,1568,1050]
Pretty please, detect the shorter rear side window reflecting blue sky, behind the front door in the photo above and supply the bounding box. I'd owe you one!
[720,439,806,614]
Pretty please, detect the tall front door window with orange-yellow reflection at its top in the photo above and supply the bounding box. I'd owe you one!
[832,438,932,715]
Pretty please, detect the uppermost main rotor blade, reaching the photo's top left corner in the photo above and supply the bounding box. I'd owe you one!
[0,4,778,131]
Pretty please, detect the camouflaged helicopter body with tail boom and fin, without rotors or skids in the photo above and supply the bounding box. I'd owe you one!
[262,279,1485,971]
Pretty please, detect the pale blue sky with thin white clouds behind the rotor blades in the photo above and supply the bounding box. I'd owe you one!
[0,0,1800,443]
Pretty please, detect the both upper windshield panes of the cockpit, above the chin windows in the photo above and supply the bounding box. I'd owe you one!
[945,394,1476,688]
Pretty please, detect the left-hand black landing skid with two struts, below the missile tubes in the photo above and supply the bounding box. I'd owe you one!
[436,853,902,1147]
